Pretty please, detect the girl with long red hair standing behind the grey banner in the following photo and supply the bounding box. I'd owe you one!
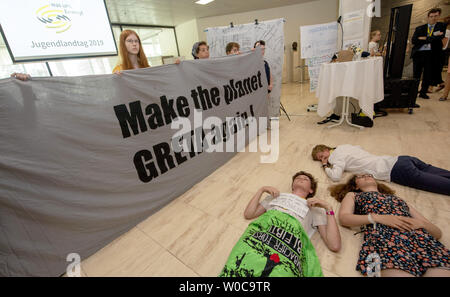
[113,30,150,73]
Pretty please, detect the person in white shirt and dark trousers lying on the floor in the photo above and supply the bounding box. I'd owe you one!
[311,144,450,196]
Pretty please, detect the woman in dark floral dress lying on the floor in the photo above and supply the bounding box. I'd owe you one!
[330,174,450,277]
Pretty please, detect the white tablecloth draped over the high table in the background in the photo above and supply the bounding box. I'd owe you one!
[316,57,384,118]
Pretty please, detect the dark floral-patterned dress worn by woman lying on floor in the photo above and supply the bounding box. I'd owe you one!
[355,192,450,276]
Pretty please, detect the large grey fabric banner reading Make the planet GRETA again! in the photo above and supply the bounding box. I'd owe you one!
[0,50,267,276]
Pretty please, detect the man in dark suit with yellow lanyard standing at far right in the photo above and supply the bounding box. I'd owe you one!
[411,8,445,99]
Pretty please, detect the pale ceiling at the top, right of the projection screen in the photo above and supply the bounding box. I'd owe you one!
[105,0,315,26]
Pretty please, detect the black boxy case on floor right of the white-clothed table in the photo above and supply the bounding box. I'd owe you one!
[375,78,419,113]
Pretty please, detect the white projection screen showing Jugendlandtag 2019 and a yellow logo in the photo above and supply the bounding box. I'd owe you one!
[0,0,117,62]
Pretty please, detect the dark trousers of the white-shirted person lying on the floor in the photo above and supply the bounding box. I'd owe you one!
[391,156,450,196]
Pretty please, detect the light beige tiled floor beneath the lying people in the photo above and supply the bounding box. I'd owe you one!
[82,83,450,276]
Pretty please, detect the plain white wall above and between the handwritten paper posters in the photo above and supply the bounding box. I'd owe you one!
[196,0,339,81]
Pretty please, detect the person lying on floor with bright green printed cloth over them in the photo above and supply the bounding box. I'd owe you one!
[219,171,341,277]
